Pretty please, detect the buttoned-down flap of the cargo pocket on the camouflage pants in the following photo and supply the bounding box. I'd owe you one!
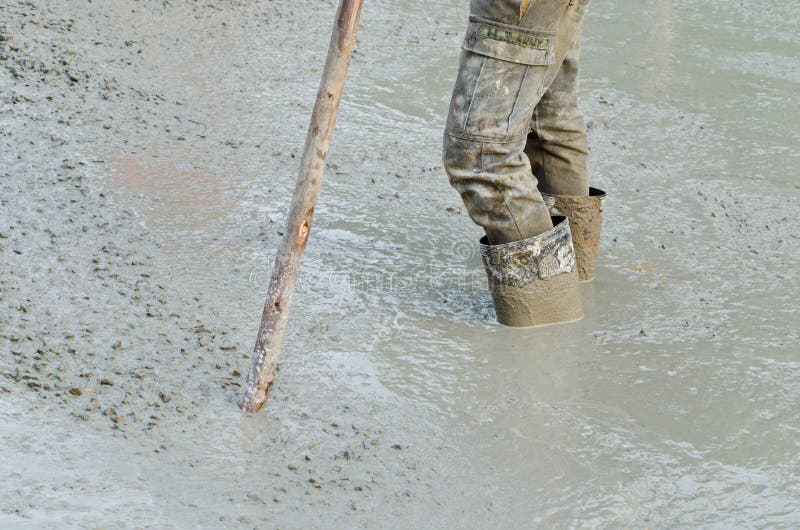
[463,16,555,66]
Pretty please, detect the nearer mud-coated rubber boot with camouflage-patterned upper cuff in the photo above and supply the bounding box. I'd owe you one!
[481,216,583,327]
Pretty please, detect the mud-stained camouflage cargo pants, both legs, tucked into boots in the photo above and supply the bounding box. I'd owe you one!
[444,0,589,244]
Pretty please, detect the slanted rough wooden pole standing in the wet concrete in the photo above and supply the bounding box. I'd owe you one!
[239,0,364,412]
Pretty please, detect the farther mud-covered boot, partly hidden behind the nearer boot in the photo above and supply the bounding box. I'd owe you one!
[542,188,606,282]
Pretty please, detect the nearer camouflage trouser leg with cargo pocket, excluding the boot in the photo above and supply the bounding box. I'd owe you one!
[444,0,587,244]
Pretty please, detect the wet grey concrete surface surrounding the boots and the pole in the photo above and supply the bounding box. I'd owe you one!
[0,0,800,528]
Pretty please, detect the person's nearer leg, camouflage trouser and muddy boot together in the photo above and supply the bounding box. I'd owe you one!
[444,0,587,326]
